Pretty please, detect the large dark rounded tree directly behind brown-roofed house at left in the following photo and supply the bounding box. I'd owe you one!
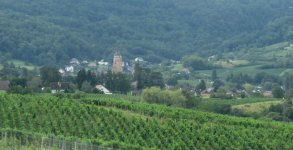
[39,66,62,86]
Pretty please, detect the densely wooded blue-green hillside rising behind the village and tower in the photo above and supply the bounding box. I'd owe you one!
[0,0,293,65]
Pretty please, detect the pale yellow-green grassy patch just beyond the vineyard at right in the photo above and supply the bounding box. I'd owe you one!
[232,101,282,112]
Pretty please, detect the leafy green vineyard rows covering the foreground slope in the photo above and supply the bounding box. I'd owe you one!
[0,94,293,150]
